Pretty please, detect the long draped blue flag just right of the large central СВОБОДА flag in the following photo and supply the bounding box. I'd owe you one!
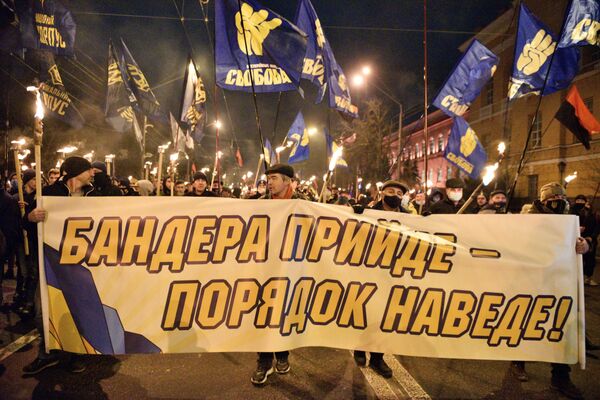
[295,0,358,118]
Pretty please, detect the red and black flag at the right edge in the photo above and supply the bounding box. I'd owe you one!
[555,85,600,150]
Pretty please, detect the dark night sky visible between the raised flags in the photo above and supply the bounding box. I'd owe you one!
[3,0,511,177]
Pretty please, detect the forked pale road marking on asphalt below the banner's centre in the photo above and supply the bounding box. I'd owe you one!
[350,351,431,400]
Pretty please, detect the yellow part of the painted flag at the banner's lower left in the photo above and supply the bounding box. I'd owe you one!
[48,286,93,354]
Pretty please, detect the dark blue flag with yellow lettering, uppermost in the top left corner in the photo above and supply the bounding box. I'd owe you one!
[17,0,77,56]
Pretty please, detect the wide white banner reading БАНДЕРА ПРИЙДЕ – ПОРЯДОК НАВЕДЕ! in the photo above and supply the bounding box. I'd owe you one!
[41,197,584,364]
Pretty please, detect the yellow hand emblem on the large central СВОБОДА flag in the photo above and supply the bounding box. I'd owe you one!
[235,3,281,56]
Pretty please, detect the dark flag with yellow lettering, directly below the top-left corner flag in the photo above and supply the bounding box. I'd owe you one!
[32,50,85,129]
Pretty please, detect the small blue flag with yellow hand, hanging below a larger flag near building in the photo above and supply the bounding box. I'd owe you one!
[444,117,487,179]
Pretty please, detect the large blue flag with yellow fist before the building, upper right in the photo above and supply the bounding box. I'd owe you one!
[508,4,579,100]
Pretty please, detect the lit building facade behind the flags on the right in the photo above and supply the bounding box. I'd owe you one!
[391,0,600,205]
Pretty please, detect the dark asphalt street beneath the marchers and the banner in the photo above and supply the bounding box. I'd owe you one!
[0,281,600,400]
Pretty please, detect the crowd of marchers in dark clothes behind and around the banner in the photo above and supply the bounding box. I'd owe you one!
[0,157,600,398]
